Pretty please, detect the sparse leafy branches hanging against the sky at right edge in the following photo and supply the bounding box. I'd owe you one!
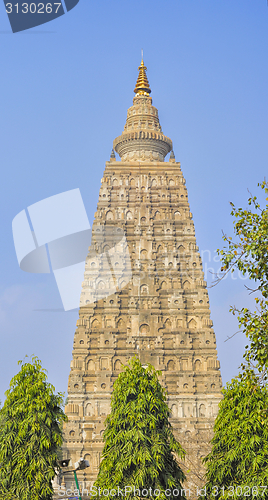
[218,181,268,379]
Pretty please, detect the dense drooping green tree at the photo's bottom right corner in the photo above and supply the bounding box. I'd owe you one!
[200,372,268,500]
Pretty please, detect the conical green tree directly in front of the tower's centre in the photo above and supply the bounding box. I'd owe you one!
[95,357,185,500]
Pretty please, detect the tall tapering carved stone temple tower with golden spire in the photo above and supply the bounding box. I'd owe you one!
[63,60,222,488]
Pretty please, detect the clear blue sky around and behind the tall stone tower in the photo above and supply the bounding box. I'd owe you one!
[0,0,268,401]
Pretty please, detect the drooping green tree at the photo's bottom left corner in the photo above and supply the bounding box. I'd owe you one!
[0,357,66,500]
